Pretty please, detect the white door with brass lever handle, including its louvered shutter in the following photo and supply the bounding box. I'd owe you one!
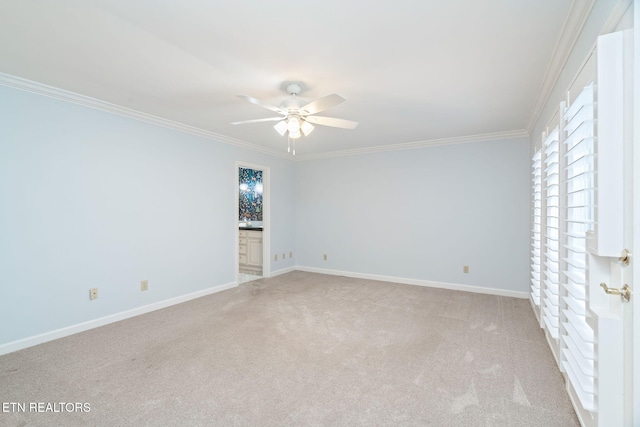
[557,31,640,427]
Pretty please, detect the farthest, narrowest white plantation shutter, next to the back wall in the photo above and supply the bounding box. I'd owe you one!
[531,150,542,310]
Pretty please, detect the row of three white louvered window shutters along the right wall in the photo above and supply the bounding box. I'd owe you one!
[531,84,596,412]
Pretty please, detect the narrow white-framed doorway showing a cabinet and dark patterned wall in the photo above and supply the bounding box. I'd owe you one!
[234,162,271,284]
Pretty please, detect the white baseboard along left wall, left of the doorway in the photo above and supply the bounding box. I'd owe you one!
[0,282,238,356]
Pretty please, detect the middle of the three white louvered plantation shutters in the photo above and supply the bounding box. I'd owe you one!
[541,128,560,341]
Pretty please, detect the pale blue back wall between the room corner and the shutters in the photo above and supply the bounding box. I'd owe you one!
[296,138,529,292]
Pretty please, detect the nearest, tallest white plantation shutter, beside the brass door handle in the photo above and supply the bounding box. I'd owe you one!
[561,84,596,411]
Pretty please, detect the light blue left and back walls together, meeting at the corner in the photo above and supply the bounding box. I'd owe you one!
[0,86,529,345]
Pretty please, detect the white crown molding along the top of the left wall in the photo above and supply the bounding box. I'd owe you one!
[0,73,291,160]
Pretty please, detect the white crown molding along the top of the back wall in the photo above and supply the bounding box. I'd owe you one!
[294,129,529,161]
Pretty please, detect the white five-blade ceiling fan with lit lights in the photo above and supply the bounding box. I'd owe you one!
[231,82,358,154]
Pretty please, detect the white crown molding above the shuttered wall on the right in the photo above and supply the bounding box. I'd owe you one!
[526,0,596,134]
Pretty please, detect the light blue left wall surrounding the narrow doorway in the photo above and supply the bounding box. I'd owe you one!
[0,86,295,345]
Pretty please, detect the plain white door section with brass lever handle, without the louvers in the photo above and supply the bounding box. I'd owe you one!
[585,31,640,426]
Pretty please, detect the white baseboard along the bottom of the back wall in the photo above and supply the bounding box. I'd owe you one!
[295,266,529,299]
